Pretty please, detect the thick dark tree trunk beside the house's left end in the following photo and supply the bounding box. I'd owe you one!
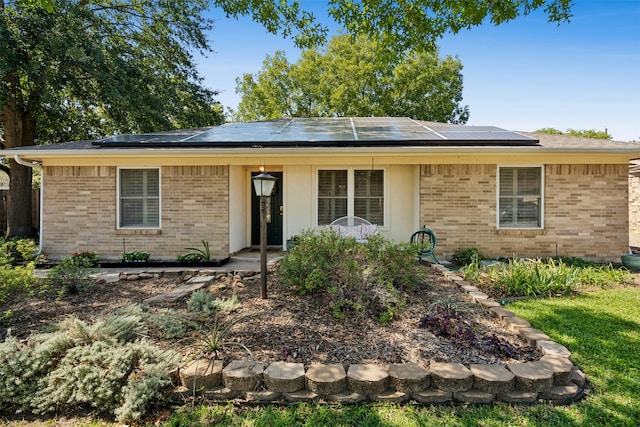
[0,104,35,238]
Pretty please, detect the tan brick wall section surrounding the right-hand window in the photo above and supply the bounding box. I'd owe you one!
[420,165,629,262]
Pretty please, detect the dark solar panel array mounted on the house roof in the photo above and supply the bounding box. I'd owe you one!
[95,117,538,147]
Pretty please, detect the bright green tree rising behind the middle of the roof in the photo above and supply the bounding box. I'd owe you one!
[236,35,469,123]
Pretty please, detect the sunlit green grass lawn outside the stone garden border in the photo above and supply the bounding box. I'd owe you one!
[163,287,640,427]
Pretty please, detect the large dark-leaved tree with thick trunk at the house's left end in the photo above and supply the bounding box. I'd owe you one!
[0,0,223,237]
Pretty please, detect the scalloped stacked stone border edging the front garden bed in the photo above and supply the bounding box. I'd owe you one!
[162,265,587,404]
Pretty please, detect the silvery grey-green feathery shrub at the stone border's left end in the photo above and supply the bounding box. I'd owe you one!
[0,315,176,422]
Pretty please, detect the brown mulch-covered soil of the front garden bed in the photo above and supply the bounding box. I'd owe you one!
[0,266,540,368]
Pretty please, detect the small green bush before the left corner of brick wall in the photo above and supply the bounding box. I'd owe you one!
[47,256,95,297]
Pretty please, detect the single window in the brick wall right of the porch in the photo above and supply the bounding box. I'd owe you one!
[498,167,542,228]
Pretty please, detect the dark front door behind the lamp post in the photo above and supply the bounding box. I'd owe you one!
[251,172,282,246]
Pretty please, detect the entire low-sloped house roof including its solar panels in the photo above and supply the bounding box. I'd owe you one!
[7,117,640,158]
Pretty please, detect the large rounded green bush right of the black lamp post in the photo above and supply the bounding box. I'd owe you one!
[277,230,422,324]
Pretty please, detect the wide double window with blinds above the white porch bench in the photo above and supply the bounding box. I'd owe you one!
[318,169,384,225]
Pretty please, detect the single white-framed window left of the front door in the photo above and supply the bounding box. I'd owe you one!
[118,169,160,228]
